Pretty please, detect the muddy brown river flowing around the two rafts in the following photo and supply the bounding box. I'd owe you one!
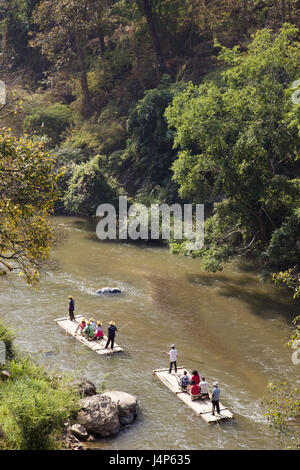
[0,217,300,450]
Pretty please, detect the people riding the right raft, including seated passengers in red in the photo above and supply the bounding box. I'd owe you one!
[165,344,220,415]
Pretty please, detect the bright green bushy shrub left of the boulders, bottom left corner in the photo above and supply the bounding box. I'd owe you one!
[0,359,79,450]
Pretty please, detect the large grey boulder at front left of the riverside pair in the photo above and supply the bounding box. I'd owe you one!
[77,395,120,437]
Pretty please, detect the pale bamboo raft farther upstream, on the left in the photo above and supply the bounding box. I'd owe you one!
[54,315,123,356]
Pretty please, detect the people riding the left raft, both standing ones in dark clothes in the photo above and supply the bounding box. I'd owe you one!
[68,295,118,349]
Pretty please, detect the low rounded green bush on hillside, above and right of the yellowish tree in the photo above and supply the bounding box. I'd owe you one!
[23,103,72,146]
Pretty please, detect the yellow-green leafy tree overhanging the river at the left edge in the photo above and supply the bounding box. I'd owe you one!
[0,126,58,283]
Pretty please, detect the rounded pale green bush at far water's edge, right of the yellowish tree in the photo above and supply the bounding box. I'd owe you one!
[64,156,116,216]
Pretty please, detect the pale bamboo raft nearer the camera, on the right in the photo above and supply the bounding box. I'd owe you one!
[153,367,233,423]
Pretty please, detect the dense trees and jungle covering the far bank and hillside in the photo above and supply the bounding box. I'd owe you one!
[0,0,300,280]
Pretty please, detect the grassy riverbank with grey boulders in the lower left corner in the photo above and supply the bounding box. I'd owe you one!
[0,322,138,450]
